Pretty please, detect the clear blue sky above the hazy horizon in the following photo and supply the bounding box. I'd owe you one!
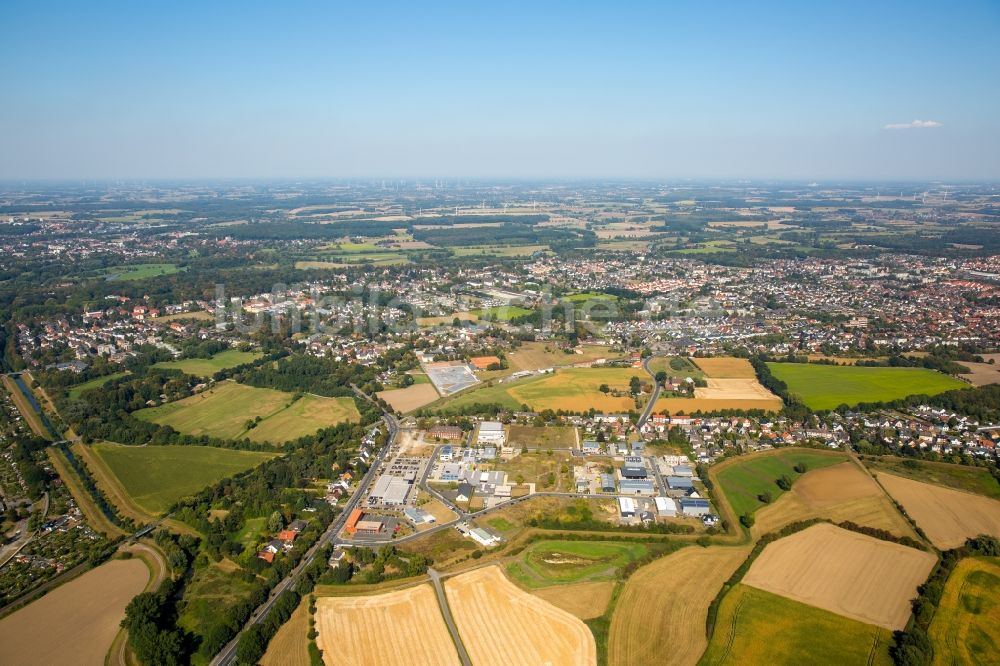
[0,0,1000,180]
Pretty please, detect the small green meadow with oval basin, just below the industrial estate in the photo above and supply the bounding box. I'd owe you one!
[507,541,649,587]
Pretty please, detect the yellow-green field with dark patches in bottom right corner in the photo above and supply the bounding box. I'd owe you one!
[928,557,1000,666]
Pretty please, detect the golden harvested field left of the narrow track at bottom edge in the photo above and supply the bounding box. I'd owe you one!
[316,584,461,666]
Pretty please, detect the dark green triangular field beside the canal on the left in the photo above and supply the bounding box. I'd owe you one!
[93,443,274,514]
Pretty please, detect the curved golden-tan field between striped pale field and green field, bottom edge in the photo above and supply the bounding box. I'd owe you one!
[608,546,750,666]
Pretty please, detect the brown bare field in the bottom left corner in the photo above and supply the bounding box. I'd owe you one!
[0,558,149,666]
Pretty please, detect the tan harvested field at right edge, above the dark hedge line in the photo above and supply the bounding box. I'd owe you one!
[876,472,1000,549]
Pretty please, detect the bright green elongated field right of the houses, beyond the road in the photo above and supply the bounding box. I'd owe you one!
[767,363,969,410]
